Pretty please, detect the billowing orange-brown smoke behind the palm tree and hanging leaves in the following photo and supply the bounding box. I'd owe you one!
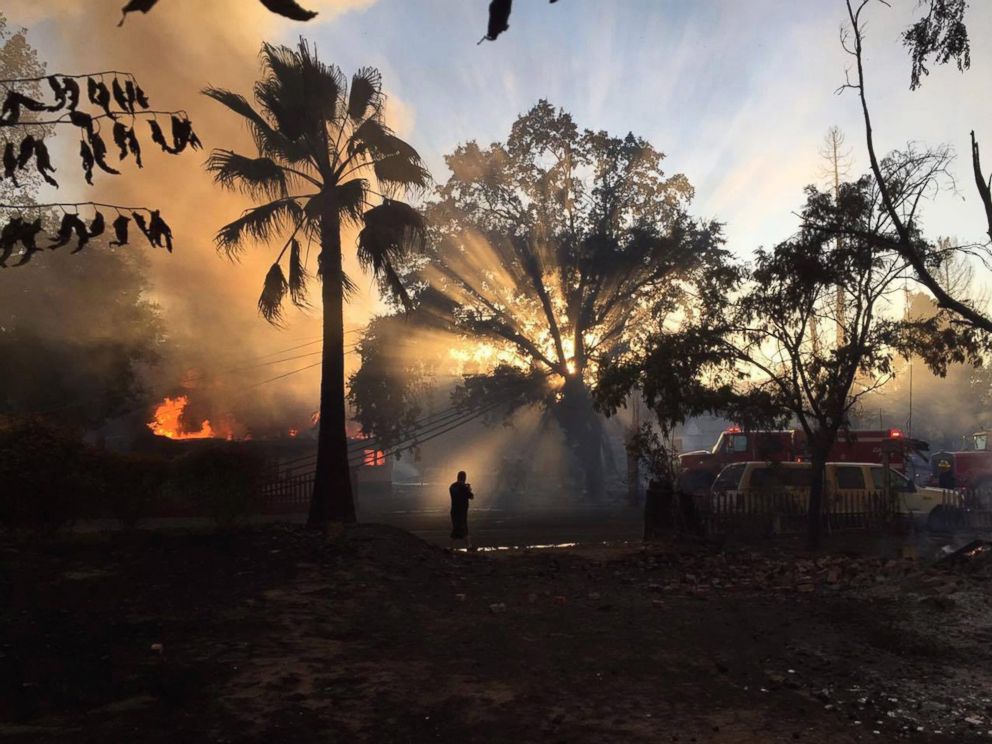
[4,0,415,433]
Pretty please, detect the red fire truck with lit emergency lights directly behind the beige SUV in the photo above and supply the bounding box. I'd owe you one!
[679,427,920,493]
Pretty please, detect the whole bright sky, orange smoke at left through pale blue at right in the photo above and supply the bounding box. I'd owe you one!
[3,0,992,416]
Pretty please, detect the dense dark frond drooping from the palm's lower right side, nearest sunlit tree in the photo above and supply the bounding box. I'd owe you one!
[358,199,427,308]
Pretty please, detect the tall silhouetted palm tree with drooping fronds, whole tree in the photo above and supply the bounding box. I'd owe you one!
[204,39,430,527]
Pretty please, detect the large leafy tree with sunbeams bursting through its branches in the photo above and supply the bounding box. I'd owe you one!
[355,101,735,496]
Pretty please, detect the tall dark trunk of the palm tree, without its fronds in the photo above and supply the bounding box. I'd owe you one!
[307,202,355,528]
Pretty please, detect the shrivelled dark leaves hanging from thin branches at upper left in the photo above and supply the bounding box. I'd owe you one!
[0,72,192,268]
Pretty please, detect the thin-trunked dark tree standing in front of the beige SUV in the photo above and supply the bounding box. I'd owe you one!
[620,171,983,549]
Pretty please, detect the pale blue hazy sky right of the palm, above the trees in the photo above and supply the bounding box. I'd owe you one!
[300,0,992,262]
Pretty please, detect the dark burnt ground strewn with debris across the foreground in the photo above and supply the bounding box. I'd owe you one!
[0,525,992,742]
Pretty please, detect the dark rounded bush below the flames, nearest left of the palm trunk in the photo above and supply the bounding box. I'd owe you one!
[168,445,265,527]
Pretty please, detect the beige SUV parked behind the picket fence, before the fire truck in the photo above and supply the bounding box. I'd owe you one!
[704,462,960,530]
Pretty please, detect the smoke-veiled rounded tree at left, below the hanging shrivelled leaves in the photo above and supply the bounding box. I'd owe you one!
[0,248,167,428]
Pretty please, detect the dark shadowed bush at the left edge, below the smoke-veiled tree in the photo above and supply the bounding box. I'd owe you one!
[0,418,96,530]
